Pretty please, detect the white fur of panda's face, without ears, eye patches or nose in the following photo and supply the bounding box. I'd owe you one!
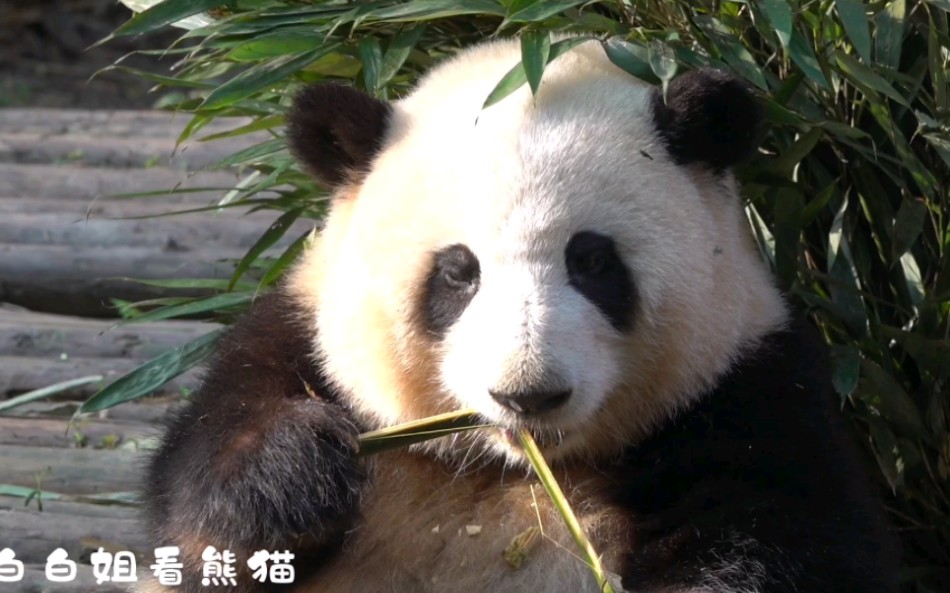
[294,41,785,458]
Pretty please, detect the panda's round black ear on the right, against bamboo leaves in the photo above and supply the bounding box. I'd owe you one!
[653,68,761,173]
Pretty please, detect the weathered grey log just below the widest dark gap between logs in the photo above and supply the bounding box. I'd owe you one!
[0,306,220,361]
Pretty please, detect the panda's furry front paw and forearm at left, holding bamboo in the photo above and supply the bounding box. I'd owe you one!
[146,397,365,551]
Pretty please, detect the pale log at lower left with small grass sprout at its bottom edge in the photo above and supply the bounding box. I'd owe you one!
[0,445,143,492]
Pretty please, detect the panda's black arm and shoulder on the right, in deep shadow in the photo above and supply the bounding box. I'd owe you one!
[610,321,899,593]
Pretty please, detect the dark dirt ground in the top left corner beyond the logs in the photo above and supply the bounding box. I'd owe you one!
[0,0,178,109]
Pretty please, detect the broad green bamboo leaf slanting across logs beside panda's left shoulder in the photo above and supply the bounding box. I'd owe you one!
[77,330,223,414]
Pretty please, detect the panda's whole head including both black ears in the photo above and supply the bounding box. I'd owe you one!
[289,41,785,461]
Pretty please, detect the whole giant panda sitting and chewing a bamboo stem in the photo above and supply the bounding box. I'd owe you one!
[140,40,898,593]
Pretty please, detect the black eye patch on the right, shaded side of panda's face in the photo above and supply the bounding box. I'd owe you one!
[564,231,637,332]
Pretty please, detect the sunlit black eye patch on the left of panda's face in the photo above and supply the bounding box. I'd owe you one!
[421,244,481,337]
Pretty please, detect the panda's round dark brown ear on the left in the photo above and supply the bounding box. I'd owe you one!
[287,84,392,187]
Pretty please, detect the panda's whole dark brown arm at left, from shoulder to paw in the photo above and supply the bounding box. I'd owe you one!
[144,290,363,591]
